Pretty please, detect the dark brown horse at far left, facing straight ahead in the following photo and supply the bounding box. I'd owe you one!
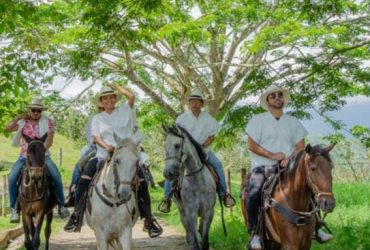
[19,134,57,250]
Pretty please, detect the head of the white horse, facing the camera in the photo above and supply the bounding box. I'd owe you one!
[109,134,140,201]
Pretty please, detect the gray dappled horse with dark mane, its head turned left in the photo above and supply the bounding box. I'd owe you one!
[163,125,216,250]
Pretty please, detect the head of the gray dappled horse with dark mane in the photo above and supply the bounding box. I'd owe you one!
[163,125,189,181]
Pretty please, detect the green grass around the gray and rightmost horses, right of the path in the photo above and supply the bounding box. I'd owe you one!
[151,165,370,250]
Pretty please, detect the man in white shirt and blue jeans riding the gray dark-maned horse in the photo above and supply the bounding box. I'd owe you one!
[159,90,235,213]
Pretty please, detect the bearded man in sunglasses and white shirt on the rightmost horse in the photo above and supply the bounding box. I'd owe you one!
[247,85,332,250]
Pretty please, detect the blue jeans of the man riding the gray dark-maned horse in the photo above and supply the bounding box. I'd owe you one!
[164,151,227,197]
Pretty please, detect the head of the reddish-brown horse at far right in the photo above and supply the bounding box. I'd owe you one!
[305,144,335,212]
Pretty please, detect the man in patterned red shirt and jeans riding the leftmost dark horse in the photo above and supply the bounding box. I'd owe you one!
[5,98,69,223]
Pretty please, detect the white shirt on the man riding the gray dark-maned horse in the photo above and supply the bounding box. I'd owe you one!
[176,110,221,149]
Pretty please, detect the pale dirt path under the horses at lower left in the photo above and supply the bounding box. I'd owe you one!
[7,221,189,250]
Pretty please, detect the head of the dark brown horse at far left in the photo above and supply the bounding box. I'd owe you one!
[22,133,48,184]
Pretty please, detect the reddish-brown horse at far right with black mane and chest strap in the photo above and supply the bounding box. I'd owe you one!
[242,144,335,250]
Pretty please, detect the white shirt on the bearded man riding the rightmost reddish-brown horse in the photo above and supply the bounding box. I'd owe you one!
[247,112,308,169]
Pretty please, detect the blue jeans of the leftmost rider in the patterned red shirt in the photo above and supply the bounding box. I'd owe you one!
[9,156,64,208]
